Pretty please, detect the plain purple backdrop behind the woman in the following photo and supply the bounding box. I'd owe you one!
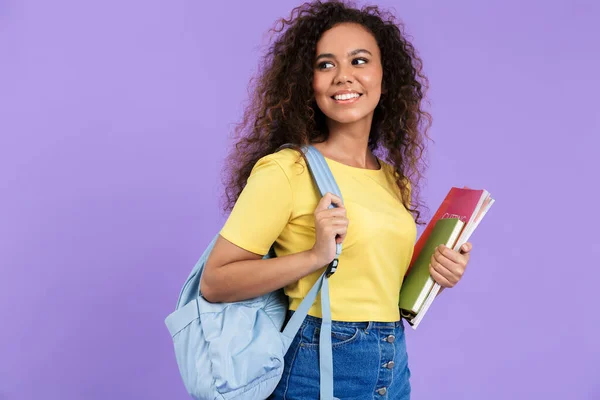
[0,0,600,400]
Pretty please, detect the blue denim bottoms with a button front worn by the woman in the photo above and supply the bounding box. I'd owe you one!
[269,315,411,400]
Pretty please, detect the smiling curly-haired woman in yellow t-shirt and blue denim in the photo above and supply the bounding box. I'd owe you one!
[201,2,471,400]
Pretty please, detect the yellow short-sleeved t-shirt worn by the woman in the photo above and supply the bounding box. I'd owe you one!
[221,149,416,322]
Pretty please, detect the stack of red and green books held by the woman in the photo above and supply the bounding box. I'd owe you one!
[399,187,495,329]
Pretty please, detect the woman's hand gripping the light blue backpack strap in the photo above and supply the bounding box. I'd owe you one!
[310,193,349,268]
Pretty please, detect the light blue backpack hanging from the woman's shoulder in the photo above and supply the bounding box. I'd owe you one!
[165,146,342,400]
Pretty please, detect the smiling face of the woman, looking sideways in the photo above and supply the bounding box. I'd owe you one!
[313,23,383,126]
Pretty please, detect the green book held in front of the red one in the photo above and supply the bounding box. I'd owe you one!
[399,218,464,318]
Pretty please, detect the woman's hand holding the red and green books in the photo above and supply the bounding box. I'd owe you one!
[429,242,473,288]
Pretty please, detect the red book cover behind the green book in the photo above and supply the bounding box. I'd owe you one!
[407,187,485,273]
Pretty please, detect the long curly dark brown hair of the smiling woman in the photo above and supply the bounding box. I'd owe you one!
[224,1,431,224]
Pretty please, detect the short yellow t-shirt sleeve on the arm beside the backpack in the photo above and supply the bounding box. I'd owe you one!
[220,156,293,255]
